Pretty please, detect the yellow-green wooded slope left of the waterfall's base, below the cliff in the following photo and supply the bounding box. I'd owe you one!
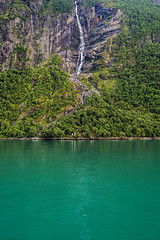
[0,55,78,137]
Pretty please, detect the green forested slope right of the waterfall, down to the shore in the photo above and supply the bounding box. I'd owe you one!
[42,0,160,137]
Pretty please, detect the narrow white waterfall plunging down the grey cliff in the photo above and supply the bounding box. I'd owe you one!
[75,1,85,75]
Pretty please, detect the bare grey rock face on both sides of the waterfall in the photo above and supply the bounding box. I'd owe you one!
[0,0,121,73]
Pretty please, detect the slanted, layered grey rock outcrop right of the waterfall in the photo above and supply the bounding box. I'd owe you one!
[75,4,122,72]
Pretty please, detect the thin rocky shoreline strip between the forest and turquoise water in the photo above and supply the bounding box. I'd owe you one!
[0,137,160,141]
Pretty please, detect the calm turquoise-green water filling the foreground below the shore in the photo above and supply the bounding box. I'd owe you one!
[0,141,160,240]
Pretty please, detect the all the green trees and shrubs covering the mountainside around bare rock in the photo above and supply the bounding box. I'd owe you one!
[0,0,160,138]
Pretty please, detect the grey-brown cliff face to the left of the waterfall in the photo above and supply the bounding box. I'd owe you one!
[0,1,79,72]
